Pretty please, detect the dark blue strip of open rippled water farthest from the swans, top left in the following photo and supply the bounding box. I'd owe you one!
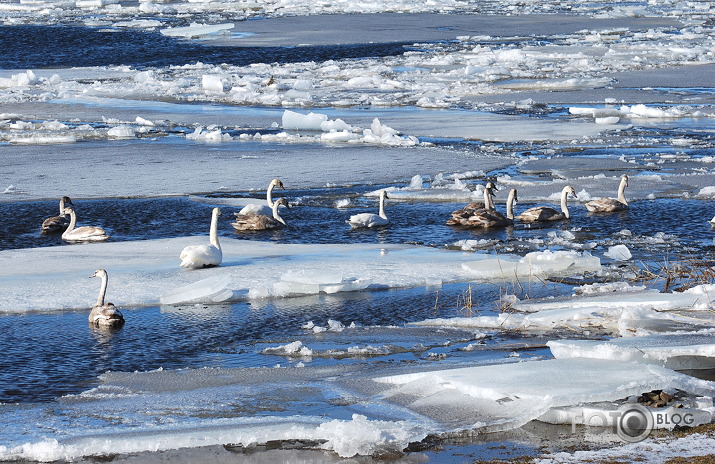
[0,25,408,69]
